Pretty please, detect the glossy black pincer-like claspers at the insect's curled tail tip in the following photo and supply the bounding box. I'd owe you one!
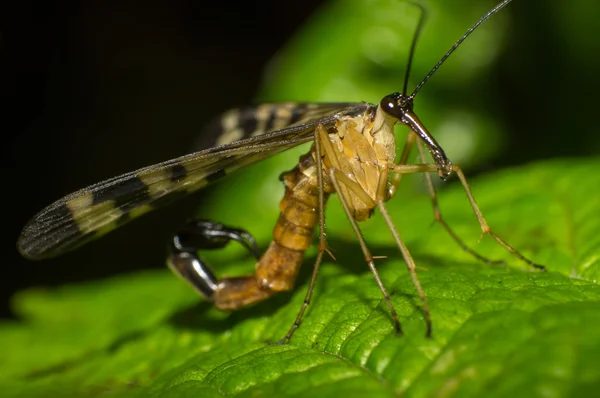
[167,220,260,301]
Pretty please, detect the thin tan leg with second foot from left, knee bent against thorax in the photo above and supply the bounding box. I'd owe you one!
[329,168,406,336]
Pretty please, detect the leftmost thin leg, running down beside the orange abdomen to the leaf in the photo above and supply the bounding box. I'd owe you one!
[277,125,331,344]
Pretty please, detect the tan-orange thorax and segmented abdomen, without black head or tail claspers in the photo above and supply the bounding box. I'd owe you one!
[214,108,395,310]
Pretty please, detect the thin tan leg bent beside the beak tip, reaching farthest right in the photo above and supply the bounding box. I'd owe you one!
[389,163,546,271]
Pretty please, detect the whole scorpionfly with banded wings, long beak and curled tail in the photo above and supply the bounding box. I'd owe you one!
[18,0,545,342]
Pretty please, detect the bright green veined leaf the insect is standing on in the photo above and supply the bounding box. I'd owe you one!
[0,160,600,397]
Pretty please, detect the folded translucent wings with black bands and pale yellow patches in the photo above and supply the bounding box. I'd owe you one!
[17,103,374,259]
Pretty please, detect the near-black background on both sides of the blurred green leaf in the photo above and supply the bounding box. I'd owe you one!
[0,0,600,316]
